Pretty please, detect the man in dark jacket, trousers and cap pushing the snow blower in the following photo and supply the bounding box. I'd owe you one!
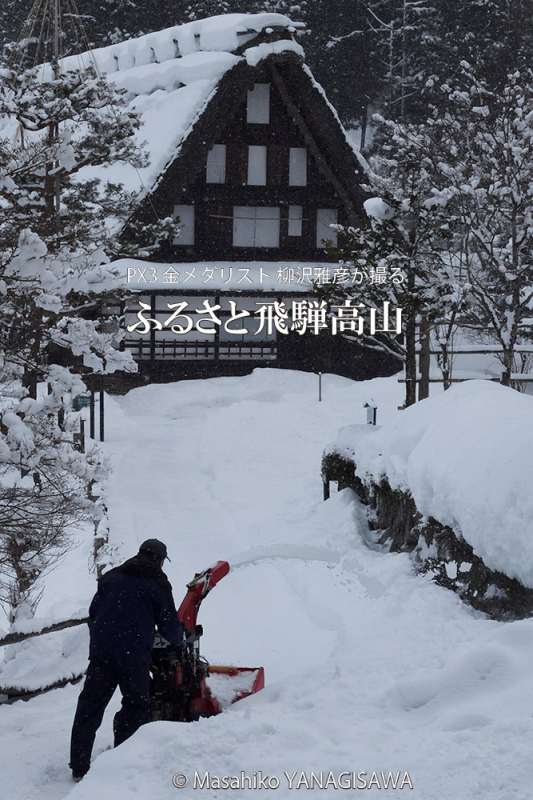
[70,539,183,780]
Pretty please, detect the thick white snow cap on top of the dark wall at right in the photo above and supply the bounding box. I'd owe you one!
[328,381,533,588]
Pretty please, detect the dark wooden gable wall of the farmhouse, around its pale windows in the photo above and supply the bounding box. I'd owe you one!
[125,54,363,261]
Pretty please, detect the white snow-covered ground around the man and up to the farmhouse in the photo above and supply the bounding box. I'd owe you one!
[0,369,533,800]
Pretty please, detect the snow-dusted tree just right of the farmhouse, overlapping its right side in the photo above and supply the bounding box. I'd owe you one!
[328,108,464,405]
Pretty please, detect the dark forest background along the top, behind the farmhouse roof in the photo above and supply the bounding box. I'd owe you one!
[0,0,533,129]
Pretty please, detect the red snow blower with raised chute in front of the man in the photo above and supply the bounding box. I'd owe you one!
[151,561,265,722]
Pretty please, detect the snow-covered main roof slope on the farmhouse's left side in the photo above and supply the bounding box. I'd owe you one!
[0,13,304,200]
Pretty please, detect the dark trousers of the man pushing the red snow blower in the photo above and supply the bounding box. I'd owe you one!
[70,655,150,775]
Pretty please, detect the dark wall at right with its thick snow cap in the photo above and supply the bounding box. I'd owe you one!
[324,381,533,614]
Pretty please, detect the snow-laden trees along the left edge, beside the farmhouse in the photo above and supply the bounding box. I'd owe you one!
[0,51,174,619]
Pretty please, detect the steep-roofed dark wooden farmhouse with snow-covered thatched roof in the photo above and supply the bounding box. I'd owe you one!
[17,13,401,382]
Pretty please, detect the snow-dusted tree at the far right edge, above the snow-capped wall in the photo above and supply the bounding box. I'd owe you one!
[431,62,533,384]
